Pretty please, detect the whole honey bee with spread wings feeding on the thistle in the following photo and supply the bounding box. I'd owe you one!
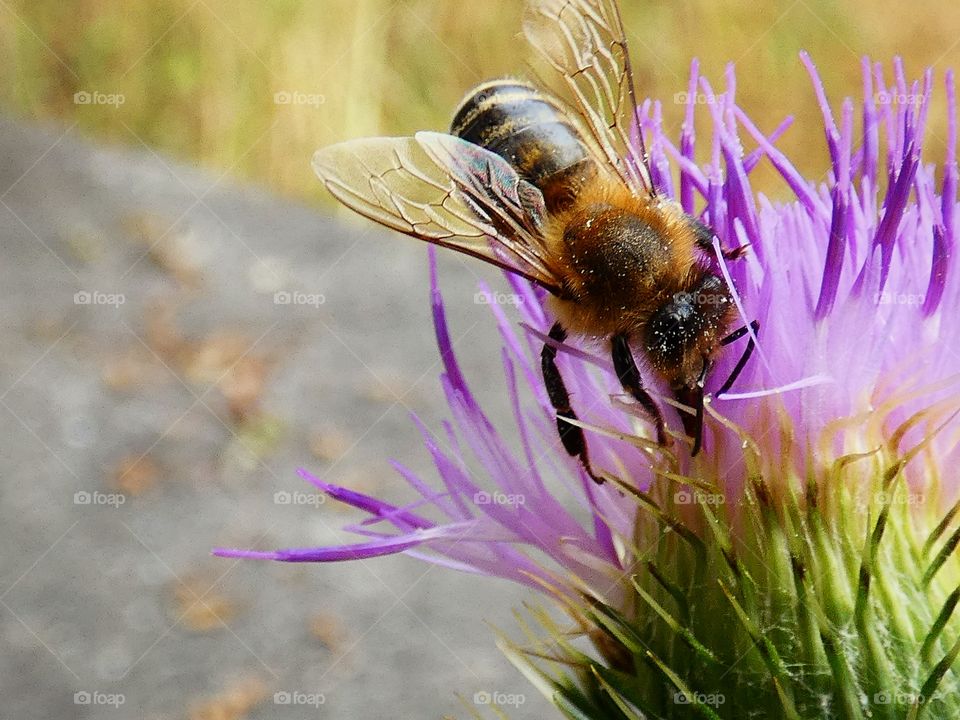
[313,0,759,482]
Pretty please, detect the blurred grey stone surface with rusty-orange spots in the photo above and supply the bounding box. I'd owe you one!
[0,120,551,720]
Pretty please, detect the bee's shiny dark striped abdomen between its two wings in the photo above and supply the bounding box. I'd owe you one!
[450,80,596,212]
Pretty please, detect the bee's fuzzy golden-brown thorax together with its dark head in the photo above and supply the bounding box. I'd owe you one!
[545,178,734,387]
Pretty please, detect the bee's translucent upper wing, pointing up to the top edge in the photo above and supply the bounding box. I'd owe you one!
[523,0,654,193]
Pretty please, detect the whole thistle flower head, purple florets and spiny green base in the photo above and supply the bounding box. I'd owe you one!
[217,56,960,718]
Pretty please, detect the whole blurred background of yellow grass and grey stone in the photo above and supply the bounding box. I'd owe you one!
[0,0,960,720]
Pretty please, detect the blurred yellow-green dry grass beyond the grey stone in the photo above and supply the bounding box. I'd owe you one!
[0,0,960,205]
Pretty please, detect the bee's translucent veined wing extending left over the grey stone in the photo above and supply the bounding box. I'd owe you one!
[313,132,561,294]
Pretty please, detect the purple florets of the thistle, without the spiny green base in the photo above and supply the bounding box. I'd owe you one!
[215,54,960,606]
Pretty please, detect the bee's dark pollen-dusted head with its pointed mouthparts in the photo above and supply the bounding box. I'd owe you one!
[647,273,735,450]
